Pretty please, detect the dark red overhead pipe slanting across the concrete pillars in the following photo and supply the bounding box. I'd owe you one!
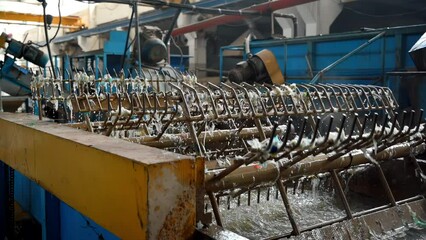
[172,0,316,36]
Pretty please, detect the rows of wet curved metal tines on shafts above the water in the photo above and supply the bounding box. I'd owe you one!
[12,44,426,237]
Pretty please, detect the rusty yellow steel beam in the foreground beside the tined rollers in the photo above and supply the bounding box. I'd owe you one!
[0,113,198,239]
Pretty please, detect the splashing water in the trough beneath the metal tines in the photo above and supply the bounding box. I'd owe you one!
[219,184,426,239]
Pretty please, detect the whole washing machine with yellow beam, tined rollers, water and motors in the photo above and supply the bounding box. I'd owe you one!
[0,1,426,239]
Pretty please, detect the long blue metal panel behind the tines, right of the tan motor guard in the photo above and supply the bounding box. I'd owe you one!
[221,25,426,85]
